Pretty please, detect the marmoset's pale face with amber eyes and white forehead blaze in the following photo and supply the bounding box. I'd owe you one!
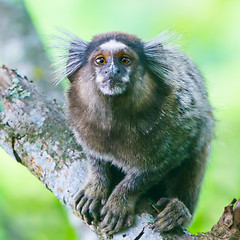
[90,40,138,96]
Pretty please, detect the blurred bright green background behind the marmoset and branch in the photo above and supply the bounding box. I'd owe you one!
[0,0,240,240]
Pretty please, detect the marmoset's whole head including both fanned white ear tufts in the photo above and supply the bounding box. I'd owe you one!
[54,32,172,99]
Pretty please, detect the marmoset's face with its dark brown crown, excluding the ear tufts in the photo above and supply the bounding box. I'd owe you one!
[79,33,144,96]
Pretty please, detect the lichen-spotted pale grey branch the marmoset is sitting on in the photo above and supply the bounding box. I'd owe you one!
[0,64,240,240]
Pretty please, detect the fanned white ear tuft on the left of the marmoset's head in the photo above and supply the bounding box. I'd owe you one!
[53,31,88,84]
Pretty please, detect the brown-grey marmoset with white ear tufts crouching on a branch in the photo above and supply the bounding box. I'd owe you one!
[55,32,214,235]
